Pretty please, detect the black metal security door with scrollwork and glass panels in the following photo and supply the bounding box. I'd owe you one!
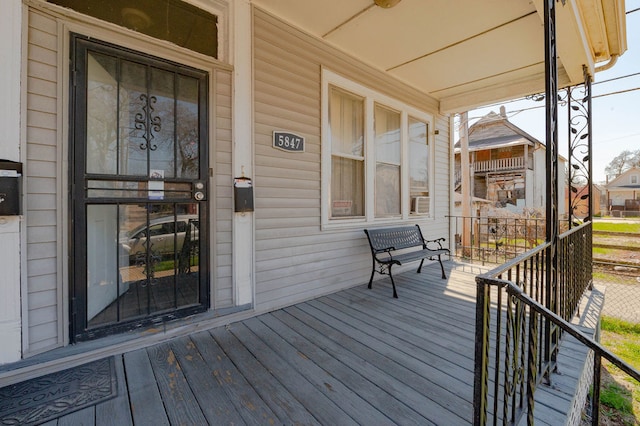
[70,35,209,340]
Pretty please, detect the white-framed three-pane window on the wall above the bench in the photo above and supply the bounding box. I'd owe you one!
[322,70,433,226]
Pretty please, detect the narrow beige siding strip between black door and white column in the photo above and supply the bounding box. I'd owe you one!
[211,70,234,309]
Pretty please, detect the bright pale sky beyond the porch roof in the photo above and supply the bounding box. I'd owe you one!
[469,0,640,183]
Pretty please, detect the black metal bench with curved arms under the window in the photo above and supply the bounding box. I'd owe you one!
[364,225,450,298]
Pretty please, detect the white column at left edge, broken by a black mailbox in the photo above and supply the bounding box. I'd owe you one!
[0,0,26,364]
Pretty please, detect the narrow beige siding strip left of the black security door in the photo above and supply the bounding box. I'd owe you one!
[25,11,63,354]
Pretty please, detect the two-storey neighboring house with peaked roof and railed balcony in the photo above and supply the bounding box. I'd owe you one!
[454,107,567,217]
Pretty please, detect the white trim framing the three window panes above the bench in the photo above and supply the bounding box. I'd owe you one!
[321,69,435,229]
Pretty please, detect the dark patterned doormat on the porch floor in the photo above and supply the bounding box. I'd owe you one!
[0,357,117,425]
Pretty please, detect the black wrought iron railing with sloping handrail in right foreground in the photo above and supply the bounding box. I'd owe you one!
[474,222,640,425]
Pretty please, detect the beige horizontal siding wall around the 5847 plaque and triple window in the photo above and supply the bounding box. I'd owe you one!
[254,9,449,310]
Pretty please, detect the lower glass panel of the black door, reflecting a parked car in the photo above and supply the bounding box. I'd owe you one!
[87,203,200,327]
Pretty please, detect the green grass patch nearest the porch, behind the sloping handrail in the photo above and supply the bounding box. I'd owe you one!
[600,316,640,425]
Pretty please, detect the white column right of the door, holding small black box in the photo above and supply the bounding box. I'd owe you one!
[231,0,255,306]
